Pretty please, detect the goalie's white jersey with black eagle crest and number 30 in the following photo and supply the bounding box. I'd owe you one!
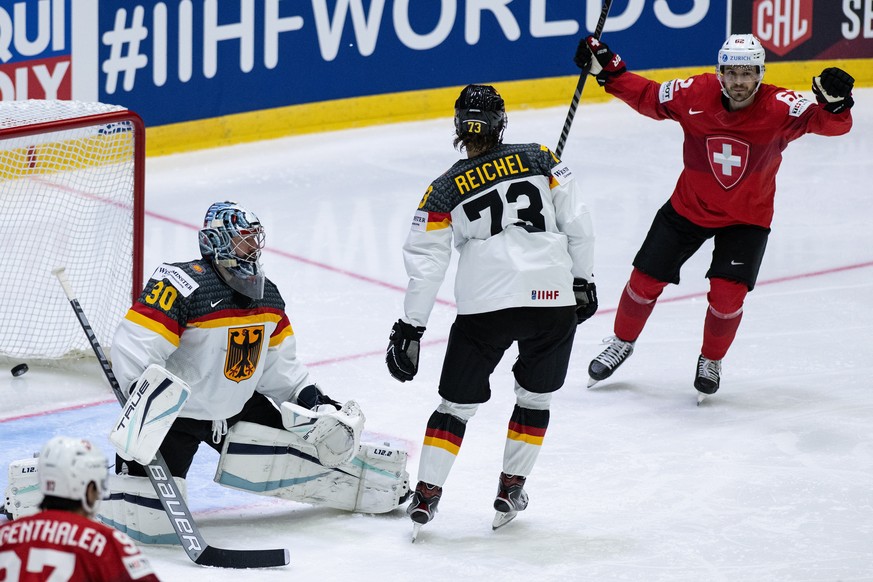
[111,260,312,420]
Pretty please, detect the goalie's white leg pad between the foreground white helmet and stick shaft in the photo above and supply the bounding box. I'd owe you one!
[97,475,185,545]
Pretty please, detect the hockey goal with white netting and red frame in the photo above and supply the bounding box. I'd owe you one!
[0,100,145,362]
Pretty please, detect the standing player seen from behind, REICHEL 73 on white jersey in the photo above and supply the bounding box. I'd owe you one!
[386,85,597,541]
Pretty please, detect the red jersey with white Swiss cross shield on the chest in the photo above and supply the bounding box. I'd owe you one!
[606,72,852,228]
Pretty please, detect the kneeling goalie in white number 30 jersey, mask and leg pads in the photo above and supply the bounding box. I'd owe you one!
[51,202,408,543]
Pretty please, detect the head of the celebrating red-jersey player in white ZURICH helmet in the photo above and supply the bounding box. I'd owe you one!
[715,34,765,102]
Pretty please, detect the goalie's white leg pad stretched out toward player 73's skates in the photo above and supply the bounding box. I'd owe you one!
[215,422,409,513]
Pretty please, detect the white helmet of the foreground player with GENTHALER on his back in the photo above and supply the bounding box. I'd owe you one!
[37,436,108,515]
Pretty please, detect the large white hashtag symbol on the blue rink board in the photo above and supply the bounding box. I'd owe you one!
[102,6,148,94]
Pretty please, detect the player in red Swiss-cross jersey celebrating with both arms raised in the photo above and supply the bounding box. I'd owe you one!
[575,34,854,401]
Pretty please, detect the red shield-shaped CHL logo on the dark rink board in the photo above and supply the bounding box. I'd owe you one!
[752,0,816,56]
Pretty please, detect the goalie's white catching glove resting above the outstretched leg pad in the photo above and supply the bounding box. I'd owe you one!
[280,400,365,467]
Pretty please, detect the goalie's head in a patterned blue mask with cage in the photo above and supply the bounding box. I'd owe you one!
[200,202,265,299]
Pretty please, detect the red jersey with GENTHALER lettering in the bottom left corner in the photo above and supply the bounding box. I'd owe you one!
[0,510,158,582]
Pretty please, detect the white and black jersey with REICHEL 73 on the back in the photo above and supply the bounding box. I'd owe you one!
[403,144,594,326]
